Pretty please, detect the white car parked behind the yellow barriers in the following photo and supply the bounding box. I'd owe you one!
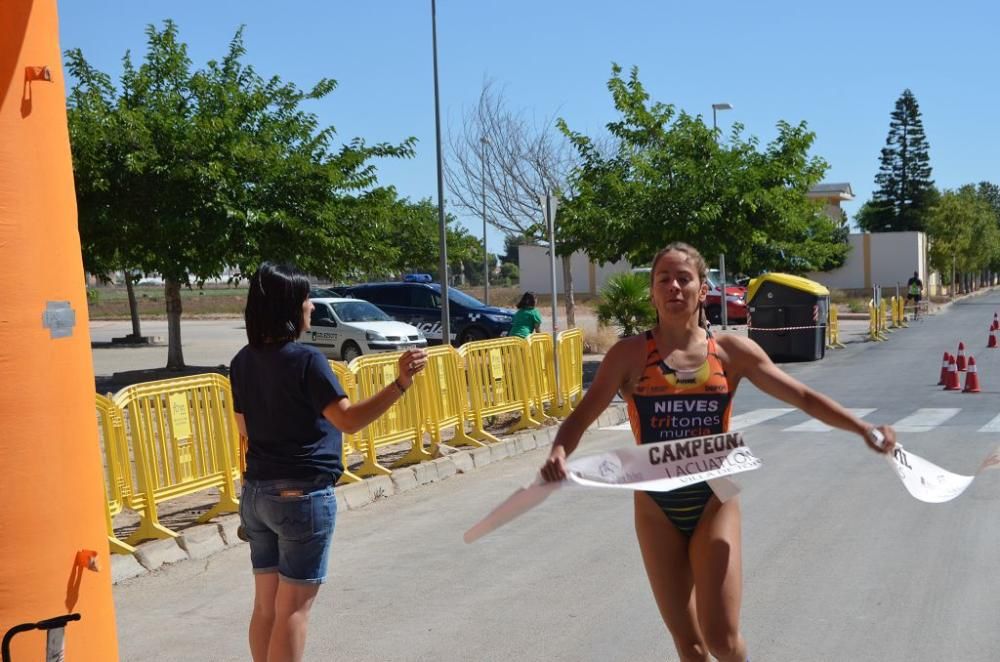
[299,298,427,362]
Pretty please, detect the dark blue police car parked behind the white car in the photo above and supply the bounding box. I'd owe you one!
[343,274,514,345]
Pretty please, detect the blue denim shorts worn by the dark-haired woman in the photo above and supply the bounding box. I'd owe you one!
[240,476,337,584]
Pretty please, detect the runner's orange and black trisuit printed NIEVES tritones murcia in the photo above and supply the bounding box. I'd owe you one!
[625,331,733,537]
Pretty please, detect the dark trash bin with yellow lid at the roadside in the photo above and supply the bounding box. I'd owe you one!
[747,274,830,362]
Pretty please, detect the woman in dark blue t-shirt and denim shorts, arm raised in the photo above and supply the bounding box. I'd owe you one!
[230,262,427,662]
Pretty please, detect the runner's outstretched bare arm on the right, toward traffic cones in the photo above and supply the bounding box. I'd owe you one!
[720,335,896,453]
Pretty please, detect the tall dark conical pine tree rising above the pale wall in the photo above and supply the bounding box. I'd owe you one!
[858,90,937,232]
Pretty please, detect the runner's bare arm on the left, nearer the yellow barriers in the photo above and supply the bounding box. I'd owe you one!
[542,339,631,481]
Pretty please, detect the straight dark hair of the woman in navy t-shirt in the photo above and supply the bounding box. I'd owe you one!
[243,262,309,346]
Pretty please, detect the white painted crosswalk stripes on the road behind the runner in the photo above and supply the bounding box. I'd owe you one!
[601,407,1000,434]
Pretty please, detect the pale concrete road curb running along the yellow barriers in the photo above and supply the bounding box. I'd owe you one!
[111,403,628,584]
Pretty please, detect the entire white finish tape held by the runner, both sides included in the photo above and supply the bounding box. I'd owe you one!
[463,432,1000,543]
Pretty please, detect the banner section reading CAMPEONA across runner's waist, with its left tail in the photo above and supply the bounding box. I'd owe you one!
[463,432,761,543]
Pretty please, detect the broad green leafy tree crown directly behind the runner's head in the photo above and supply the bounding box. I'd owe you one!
[557,65,847,272]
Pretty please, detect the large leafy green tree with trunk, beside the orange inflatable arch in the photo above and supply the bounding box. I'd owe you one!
[66,21,413,369]
